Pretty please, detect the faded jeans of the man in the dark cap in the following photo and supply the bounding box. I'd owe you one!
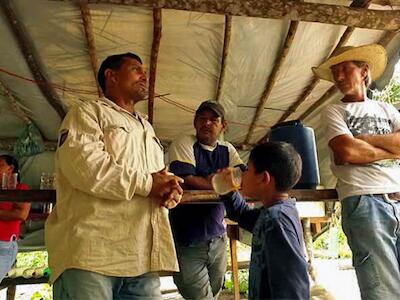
[174,236,226,300]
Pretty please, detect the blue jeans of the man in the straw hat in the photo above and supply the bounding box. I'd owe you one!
[342,194,400,300]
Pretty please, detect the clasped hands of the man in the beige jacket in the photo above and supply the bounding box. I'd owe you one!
[149,168,184,205]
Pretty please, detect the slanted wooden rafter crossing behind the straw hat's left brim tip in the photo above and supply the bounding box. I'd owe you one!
[277,0,371,123]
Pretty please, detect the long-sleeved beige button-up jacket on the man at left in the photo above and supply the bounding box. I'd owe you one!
[45,99,178,282]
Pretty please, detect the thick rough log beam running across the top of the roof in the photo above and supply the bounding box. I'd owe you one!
[85,0,400,30]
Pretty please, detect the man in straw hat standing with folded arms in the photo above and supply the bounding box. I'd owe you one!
[313,44,400,299]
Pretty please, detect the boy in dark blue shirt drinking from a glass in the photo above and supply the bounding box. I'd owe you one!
[221,142,310,299]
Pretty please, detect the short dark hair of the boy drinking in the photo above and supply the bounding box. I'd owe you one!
[249,142,302,192]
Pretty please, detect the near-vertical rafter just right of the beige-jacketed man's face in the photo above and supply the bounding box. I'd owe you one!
[148,8,162,124]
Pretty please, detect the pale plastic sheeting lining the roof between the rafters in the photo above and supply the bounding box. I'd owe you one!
[0,0,400,187]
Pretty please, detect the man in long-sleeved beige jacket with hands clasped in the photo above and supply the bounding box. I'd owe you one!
[45,53,182,300]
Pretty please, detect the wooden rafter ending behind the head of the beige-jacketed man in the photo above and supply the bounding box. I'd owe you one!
[78,0,103,97]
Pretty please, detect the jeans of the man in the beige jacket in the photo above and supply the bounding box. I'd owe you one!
[53,269,162,300]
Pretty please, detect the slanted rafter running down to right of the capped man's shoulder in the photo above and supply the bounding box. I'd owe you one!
[244,22,299,144]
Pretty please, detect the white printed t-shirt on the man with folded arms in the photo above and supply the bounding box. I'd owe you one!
[321,99,400,200]
